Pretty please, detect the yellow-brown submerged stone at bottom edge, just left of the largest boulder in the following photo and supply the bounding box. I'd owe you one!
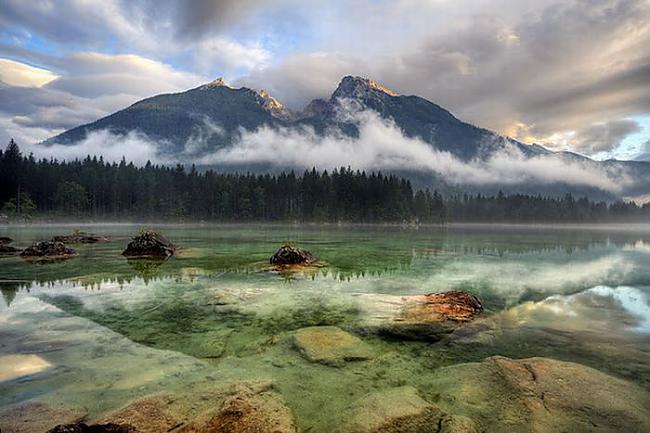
[340,386,443,433]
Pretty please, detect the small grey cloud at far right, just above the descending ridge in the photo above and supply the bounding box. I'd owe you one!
[572,119,641,154]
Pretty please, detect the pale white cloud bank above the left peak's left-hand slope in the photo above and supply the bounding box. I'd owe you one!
[0,52,206,143]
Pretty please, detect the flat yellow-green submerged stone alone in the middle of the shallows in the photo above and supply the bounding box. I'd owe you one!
[294,326,374,367]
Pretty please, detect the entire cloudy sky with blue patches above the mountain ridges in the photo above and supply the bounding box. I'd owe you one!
[0,0,650,160]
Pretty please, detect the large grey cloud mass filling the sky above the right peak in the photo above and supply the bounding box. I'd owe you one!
[241,0,650,152]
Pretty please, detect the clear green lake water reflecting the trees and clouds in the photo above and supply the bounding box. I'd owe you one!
[0,225,650,432]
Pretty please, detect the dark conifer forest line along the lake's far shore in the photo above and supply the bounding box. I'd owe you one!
[0,140,650,223]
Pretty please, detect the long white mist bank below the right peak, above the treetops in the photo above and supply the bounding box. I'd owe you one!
[197,102,632,192]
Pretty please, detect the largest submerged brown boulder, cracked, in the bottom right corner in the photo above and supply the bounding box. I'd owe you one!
[434,357,650,433]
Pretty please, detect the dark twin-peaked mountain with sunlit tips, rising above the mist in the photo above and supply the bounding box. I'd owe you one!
[45,76,547,160]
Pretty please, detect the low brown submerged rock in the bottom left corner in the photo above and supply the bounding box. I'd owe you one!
[0,401,87,433]
